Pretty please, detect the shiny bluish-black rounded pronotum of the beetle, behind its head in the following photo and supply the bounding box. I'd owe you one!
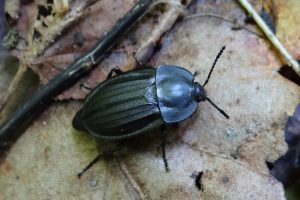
[155,65,201,123]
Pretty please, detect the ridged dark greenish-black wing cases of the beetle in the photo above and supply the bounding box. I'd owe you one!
[73,68,164,139]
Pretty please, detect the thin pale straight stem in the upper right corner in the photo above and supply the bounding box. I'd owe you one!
[238,0,300,76]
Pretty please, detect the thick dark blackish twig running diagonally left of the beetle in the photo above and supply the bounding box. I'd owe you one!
[0,0,152,145]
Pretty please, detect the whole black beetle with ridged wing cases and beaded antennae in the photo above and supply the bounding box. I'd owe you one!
[72,47,229,176]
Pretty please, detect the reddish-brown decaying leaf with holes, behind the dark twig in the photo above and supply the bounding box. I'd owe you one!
[12,0,175,100]
